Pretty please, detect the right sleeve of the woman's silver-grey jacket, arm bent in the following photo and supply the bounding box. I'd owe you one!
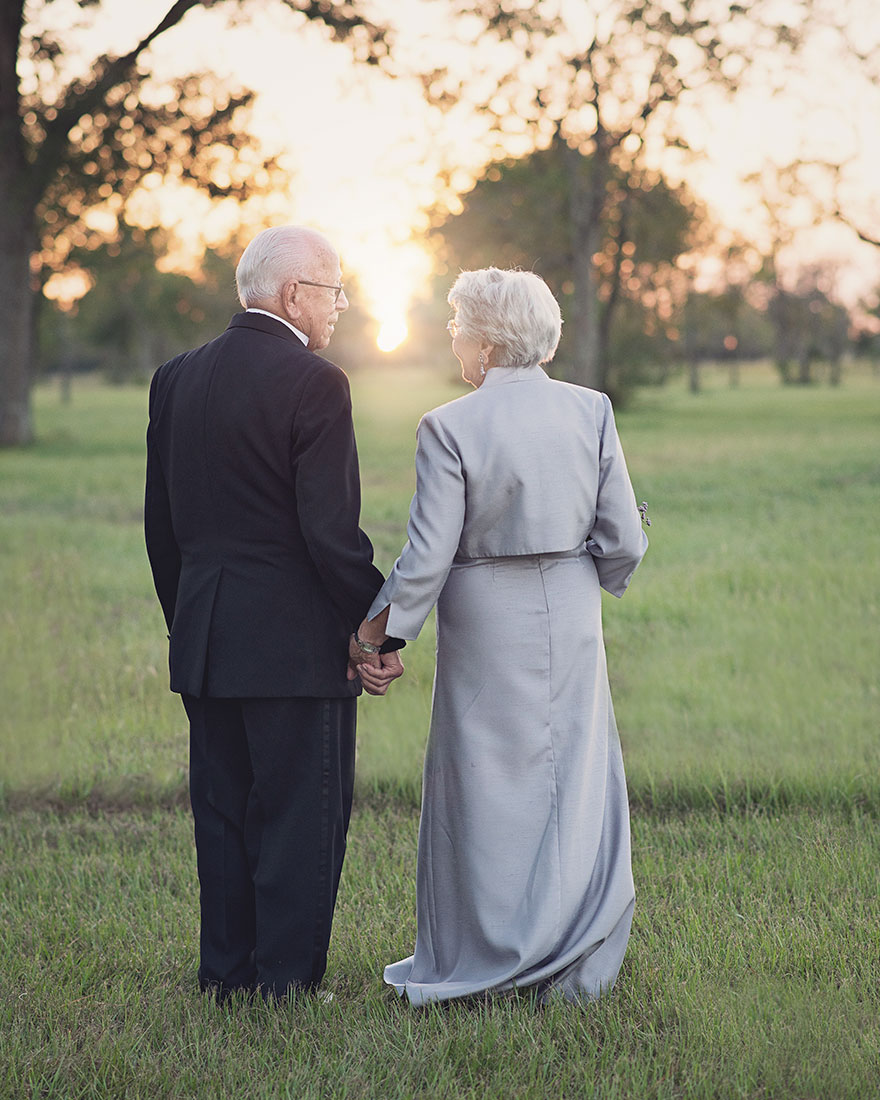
[586,394,648,596]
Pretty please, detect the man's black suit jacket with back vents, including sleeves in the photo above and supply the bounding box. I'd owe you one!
[144,314,393,697]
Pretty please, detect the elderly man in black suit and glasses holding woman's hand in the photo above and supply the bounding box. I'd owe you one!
[145,227,403,997]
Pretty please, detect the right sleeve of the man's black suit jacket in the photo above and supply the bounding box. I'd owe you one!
[290,364,383,629]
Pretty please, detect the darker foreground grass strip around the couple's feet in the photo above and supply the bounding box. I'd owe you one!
[0,804,880,1100]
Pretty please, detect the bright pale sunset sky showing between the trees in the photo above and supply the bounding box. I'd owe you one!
[27,0,880,347]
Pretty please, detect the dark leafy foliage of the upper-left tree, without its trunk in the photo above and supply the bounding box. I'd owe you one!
[19,0,384,279]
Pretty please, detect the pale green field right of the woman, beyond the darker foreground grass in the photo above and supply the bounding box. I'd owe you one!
[607,369,880,809]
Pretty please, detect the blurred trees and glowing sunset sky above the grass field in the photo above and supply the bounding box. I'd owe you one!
[0,0,880,429]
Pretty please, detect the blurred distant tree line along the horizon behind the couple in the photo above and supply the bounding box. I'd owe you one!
[40,132,880,400]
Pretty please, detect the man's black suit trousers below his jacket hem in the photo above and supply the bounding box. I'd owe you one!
[184,695,358,997]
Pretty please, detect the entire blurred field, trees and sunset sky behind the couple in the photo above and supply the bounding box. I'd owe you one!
[0,0,880,809]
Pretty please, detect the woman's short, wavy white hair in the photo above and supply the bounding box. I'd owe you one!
[448,267,562,366]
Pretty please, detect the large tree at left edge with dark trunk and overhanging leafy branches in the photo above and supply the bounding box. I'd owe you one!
[0,0,387,447]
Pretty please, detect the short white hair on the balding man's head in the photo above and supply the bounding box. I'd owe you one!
[235,226,338,309]
